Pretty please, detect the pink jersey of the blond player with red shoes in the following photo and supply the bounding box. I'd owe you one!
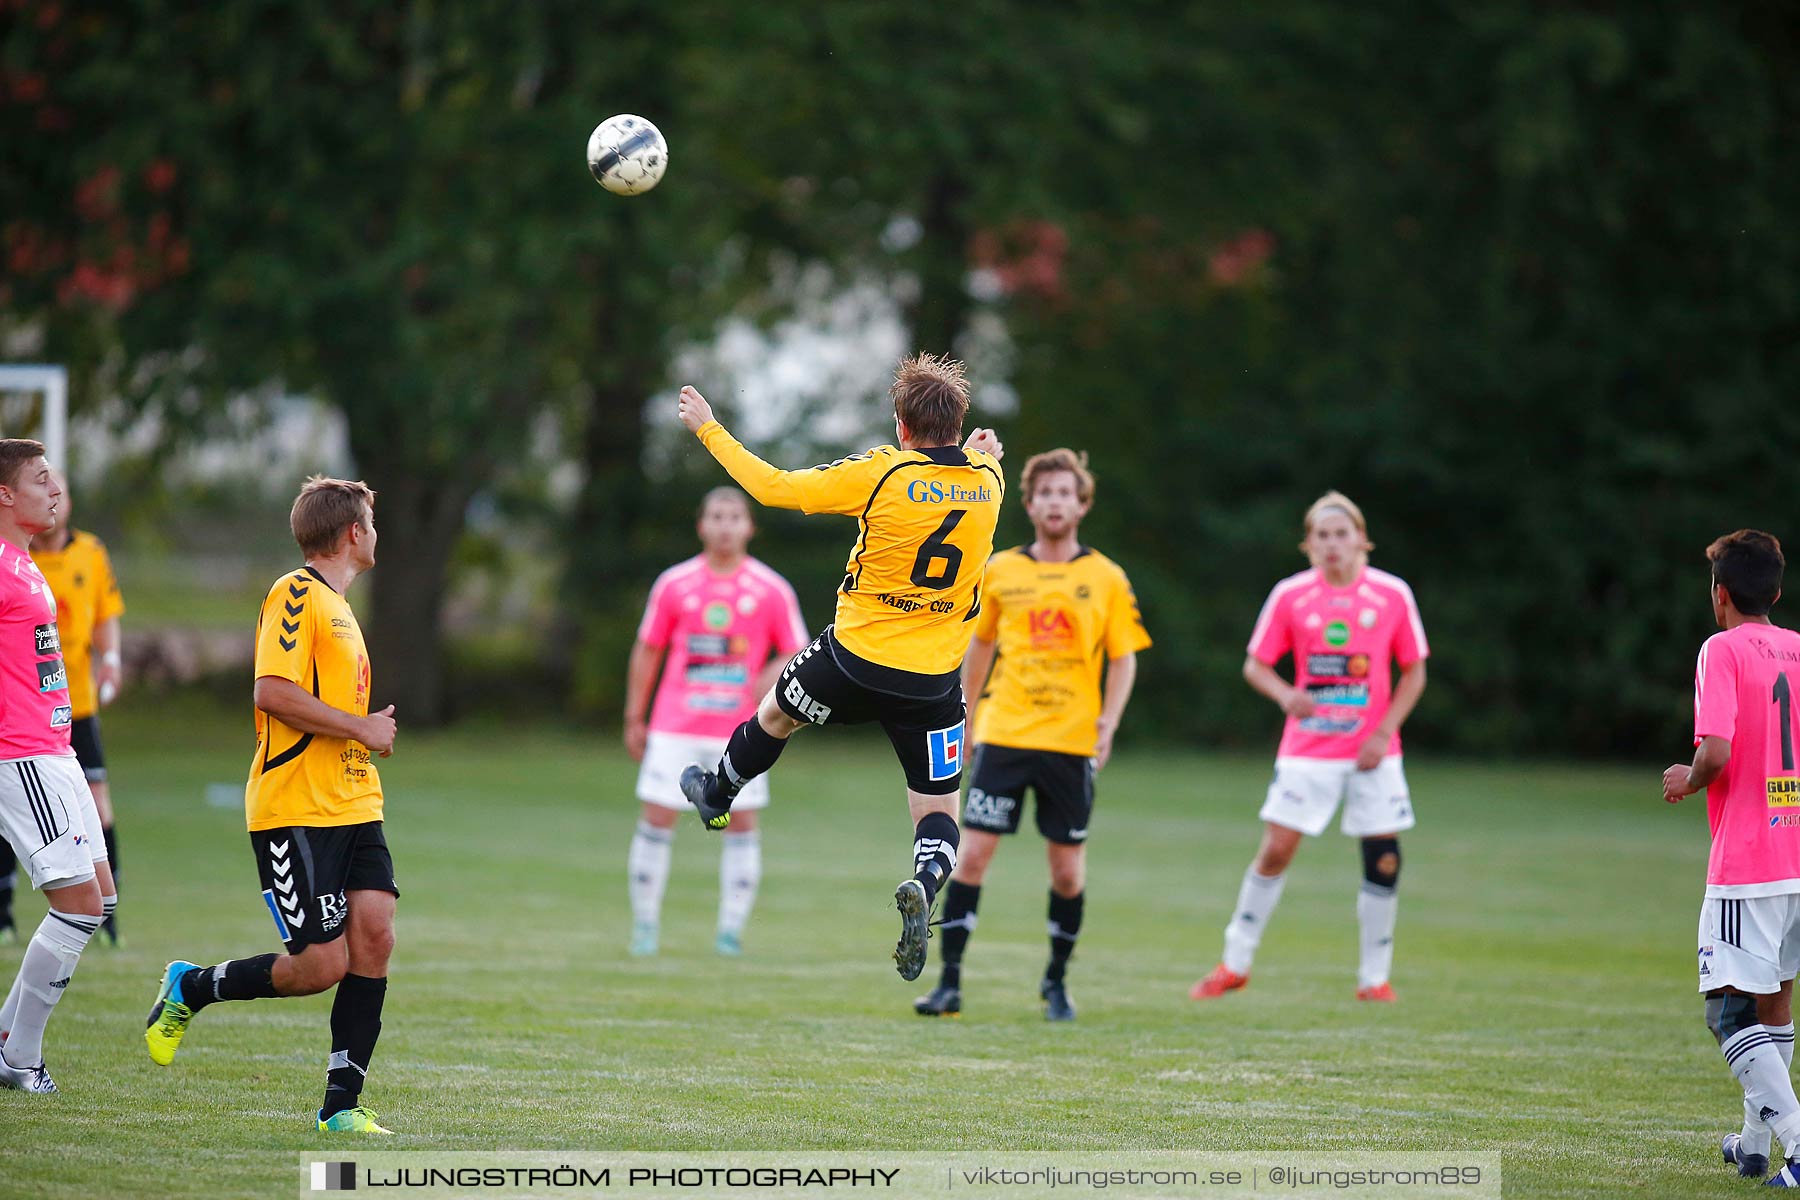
[1249,567,1431,759]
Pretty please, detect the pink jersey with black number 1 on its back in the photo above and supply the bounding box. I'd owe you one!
[1694,622,1800,896]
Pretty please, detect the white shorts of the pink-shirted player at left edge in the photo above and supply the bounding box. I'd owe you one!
[0,754,106,889]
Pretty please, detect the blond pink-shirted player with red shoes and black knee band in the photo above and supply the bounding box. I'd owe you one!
[1188,491,1431,1000]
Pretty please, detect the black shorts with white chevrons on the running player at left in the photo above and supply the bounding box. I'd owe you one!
[250,820,400,954]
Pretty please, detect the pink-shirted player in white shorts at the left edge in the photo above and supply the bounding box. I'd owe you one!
[0,437,119,1094]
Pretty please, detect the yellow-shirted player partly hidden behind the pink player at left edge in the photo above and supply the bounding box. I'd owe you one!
[0,475,124,946]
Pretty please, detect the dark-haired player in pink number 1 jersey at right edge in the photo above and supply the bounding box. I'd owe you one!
[1663,529,1800,1187]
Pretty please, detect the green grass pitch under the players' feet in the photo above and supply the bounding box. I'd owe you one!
[0,705,1739,1198]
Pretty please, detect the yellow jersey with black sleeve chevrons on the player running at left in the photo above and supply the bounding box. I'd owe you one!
[243,567,382,833]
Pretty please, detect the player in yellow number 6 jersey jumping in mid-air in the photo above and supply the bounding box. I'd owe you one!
[679,354,1006,979]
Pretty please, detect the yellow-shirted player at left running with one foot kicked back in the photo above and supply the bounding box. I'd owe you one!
[144,477,400,1133]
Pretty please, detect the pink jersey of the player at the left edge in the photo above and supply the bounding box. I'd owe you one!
[0,542,72,759]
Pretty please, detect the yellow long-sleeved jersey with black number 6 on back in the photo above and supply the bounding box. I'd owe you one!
[698,421,1006,675]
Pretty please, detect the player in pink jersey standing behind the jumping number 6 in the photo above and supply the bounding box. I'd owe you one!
[625,488,812,955]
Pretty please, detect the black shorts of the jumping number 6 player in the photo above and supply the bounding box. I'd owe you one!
[776,626,963,795]
